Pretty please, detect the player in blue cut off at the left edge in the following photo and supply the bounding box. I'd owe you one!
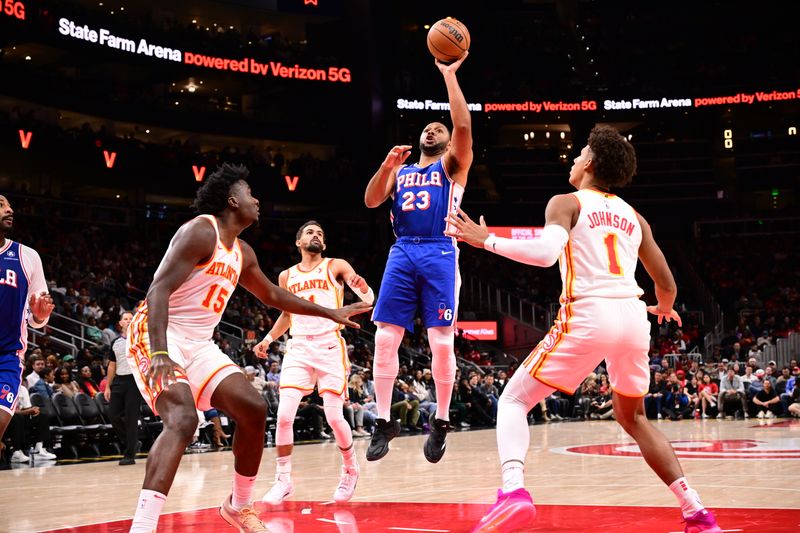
[0,195,54,446]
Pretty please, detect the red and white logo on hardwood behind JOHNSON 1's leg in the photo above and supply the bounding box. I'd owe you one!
[550,439,800,460]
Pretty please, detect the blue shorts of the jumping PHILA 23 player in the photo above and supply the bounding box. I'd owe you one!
[372,237,461,332]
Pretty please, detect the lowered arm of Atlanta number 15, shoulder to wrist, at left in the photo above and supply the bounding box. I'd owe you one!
[146,219,217,353]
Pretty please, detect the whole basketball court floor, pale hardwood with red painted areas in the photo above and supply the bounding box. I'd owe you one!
[0,419,800,533]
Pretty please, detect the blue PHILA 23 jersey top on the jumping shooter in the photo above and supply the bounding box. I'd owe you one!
[391,159,464,238]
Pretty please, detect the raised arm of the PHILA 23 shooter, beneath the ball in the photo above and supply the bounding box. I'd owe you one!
[436,52,472,185]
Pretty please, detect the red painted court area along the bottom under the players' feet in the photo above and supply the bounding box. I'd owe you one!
[40,502,800,533]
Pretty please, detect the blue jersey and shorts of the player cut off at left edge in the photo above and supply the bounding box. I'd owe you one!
[0,240,28,415]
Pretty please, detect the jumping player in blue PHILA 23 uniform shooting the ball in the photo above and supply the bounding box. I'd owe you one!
[364,53,472,463]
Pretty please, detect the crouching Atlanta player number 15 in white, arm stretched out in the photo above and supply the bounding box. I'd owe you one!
[127,164,370,533]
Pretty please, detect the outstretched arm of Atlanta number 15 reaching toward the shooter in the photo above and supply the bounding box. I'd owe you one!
[239,241,370,328]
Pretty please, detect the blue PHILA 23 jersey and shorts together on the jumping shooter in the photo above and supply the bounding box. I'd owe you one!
[372,159,464,331]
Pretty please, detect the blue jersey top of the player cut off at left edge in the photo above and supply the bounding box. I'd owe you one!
[0,240,28,354]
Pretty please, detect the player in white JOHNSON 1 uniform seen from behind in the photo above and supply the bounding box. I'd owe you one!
[450,126,722,533]
